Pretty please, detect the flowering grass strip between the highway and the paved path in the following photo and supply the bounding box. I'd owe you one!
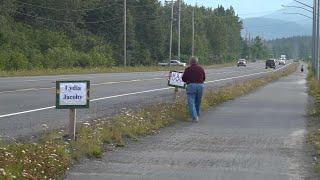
[0,65,297,179]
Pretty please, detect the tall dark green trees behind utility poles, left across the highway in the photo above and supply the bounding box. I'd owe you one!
[0,0,246,71]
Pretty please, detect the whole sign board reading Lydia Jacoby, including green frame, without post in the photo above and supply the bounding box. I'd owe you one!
[56,81,90,109]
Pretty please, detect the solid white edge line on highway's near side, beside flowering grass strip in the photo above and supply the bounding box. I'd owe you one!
[0,63,291,118]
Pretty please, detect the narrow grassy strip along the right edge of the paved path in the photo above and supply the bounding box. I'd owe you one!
[307,70,320,174]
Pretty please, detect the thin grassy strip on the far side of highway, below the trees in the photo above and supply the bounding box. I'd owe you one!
[0,63,235,77]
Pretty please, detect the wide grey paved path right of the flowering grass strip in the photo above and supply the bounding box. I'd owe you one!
[66,64,316,180]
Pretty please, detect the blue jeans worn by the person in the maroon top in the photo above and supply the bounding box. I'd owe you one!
[187,83,204,119]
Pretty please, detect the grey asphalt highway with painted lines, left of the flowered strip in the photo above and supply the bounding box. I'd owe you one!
[0,62,290,138]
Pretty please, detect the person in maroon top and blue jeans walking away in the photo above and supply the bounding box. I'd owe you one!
[182,57,206,122]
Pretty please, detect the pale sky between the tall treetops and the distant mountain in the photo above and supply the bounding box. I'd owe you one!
[184,0,293,18]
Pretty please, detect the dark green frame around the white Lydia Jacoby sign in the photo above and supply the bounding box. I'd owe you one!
[56,80,90,109]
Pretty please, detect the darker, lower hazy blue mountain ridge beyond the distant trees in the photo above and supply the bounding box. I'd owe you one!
[242,17,311,39]
